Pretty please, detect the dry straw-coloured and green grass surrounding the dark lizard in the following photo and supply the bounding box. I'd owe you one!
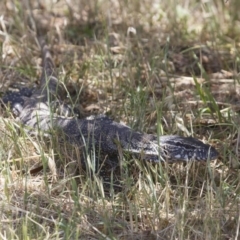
[0,0,240,239]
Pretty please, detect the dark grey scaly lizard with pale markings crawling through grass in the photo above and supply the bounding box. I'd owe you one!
[2,40,218,169]
